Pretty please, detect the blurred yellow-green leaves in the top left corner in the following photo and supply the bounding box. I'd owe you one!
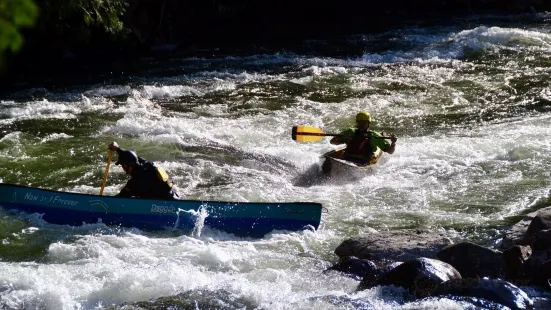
[0,0,38,53]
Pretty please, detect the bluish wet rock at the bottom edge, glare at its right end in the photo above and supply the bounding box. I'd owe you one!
[432,279,534,309]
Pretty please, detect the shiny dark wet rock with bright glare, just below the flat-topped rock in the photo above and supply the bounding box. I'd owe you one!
[358,257,461,297]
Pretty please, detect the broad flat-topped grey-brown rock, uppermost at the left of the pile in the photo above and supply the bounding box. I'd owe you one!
[335,229,453,261]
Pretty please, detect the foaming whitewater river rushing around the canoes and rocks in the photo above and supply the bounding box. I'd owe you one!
[0,14,551,310]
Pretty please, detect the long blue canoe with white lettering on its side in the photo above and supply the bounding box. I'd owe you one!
[0,183,322,237]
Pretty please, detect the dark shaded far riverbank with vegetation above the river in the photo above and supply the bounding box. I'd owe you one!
[0,0,551,90]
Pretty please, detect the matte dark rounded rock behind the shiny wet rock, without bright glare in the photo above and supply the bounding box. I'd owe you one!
[436,242,505,278]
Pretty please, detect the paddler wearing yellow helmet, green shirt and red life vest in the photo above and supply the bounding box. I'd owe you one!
[329,111,398,165]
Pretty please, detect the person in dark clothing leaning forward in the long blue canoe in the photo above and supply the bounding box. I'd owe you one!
[108,142,178,199]
